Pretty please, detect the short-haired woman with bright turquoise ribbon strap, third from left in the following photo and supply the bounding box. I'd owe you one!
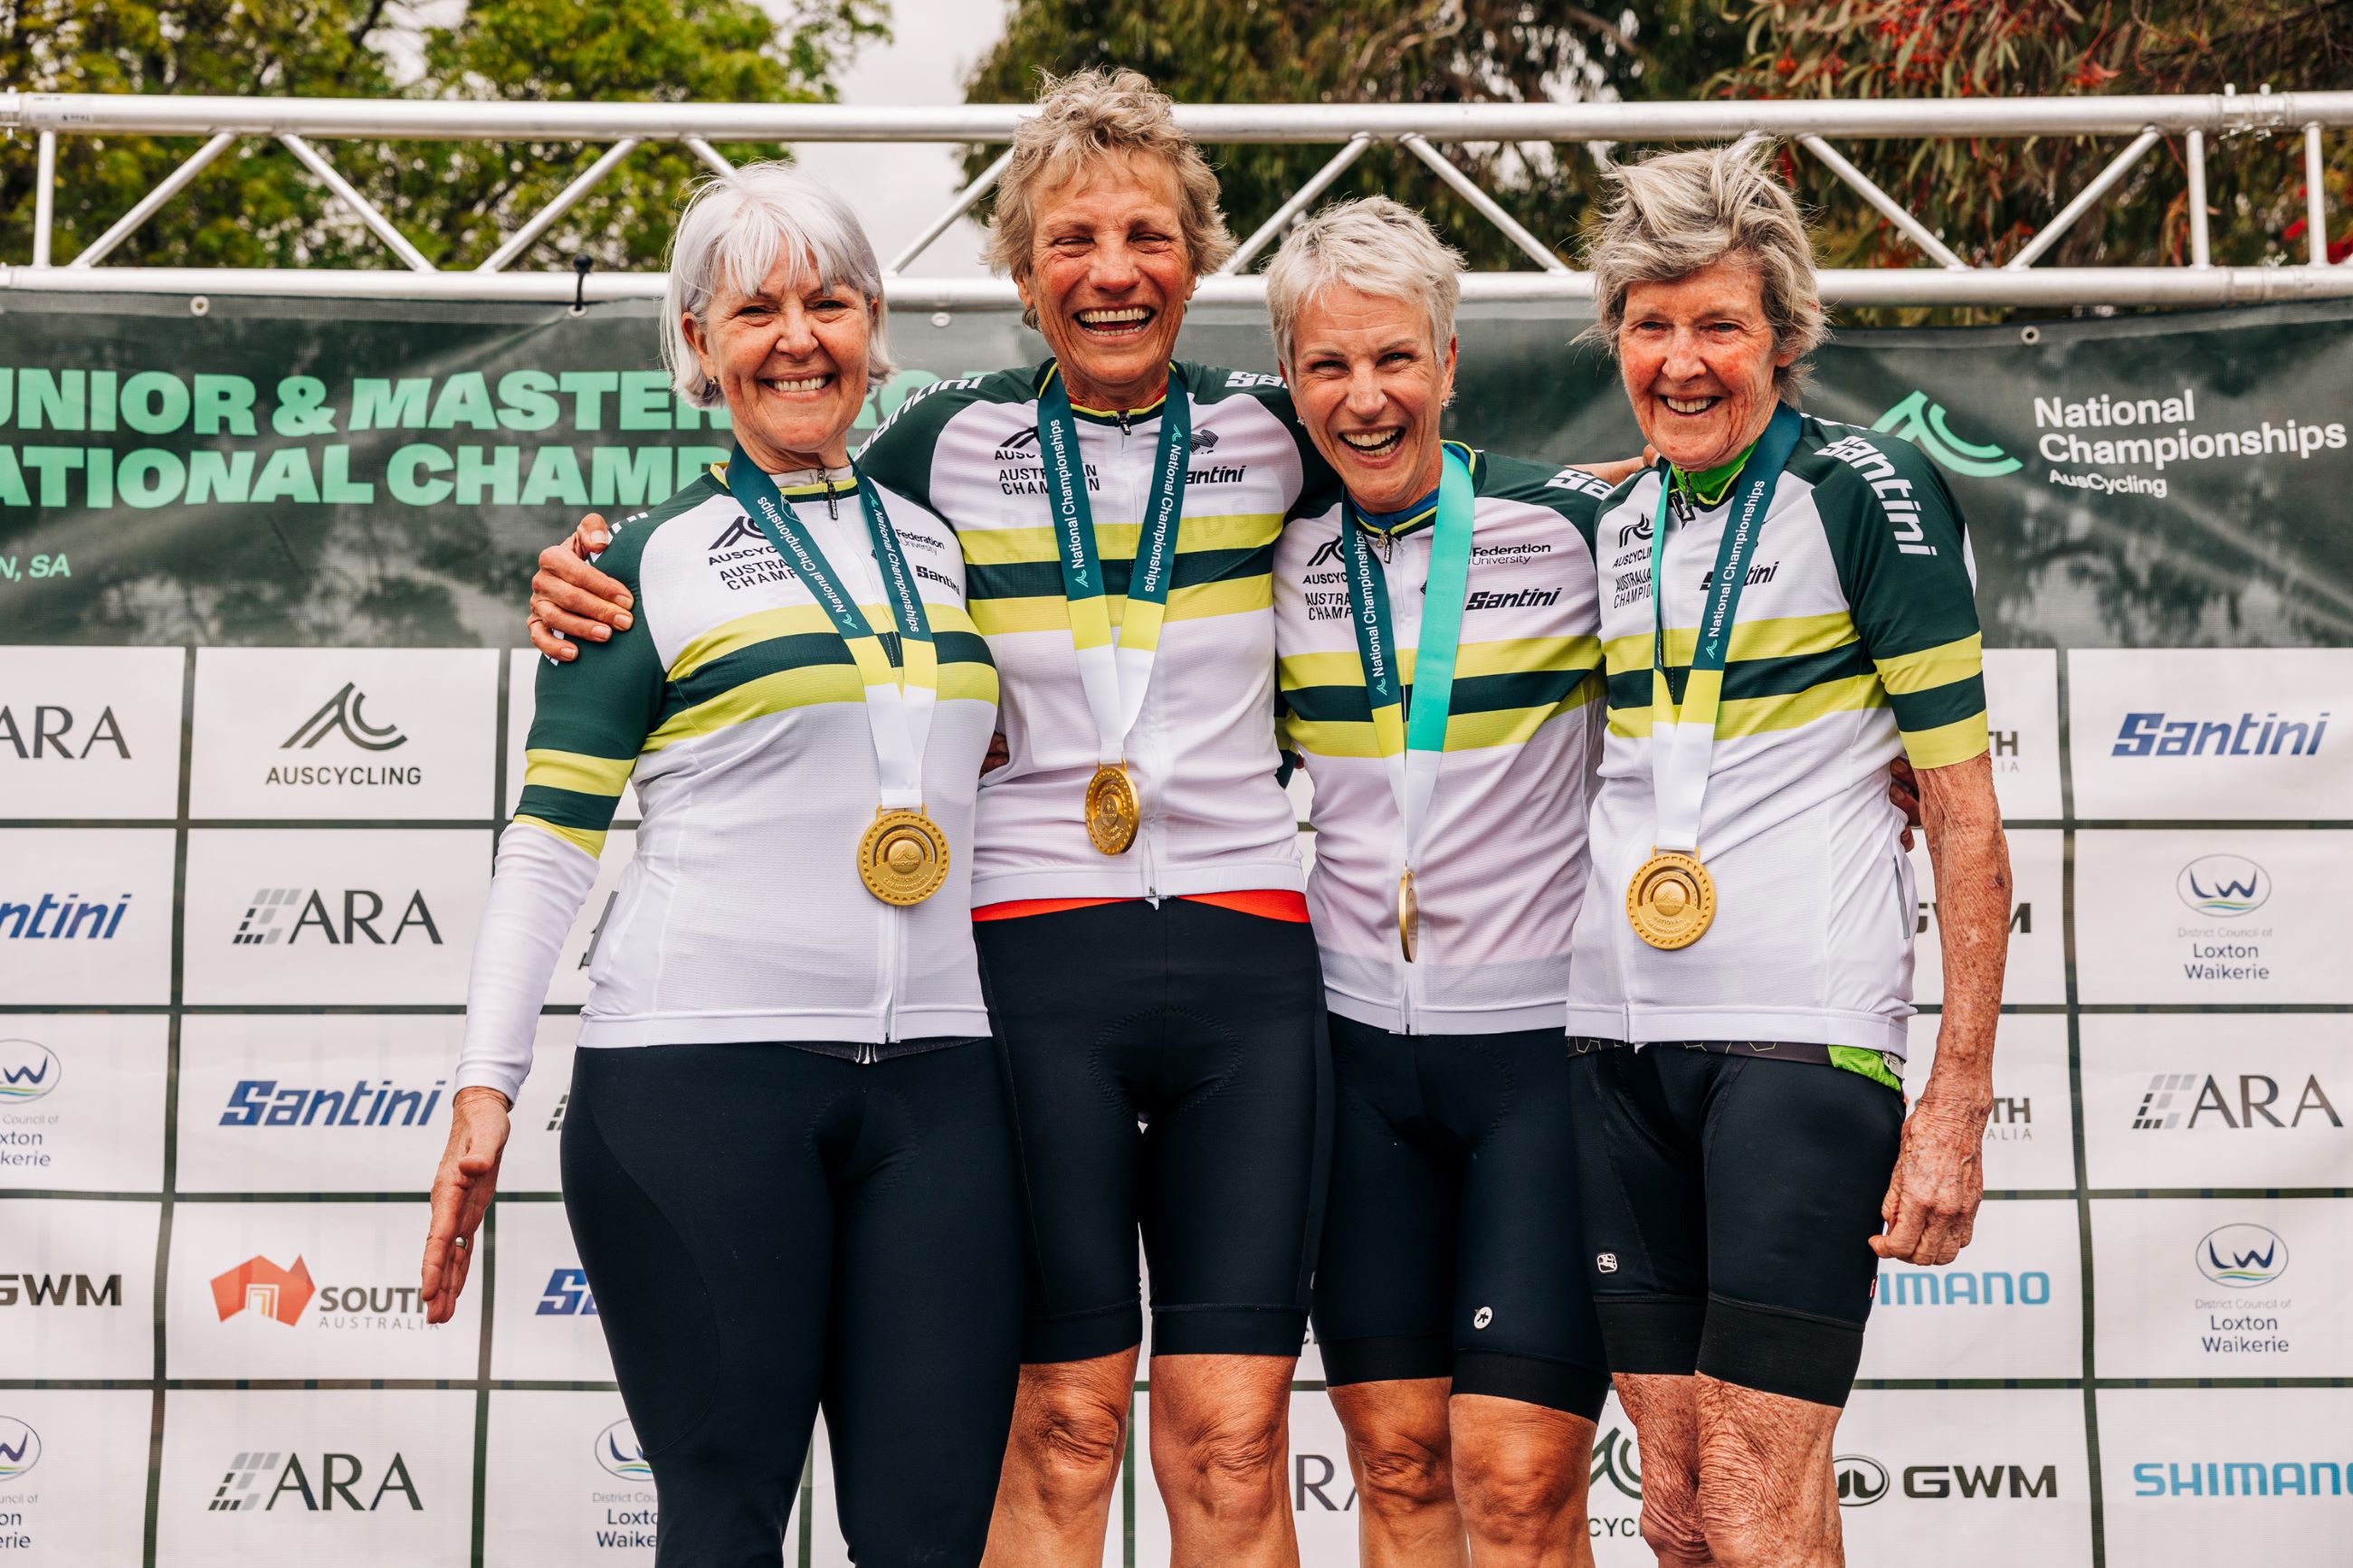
[1266,197,1633,1568]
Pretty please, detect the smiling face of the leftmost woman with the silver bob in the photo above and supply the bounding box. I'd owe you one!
[682,259,882,472]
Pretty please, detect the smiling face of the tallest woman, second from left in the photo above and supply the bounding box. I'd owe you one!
[1015,157,1193,412]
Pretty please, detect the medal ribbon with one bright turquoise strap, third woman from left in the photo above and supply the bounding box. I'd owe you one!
[1341,442,1473,883]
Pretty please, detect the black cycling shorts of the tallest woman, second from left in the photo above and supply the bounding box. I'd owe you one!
[972,898,1329,1361]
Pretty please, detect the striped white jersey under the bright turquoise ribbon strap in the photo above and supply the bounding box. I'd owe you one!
[1275,451,1609,1034]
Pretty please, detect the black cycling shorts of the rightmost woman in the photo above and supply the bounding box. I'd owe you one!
[1569,1039,1903,1406]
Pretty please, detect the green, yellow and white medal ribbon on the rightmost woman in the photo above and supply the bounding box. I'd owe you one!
[1650,404,1805,853]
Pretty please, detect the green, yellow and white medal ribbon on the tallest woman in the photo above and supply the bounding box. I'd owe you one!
[1038,365,1193,764]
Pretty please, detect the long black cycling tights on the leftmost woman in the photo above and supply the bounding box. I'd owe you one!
[562,1039,1021,1568]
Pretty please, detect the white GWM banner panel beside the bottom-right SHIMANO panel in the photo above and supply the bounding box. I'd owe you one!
[1835,1390,2099,1568]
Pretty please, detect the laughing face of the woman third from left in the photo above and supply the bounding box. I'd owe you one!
[1282,287,1454,512]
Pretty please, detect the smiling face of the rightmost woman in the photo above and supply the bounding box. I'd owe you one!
[1616,256,1797,472]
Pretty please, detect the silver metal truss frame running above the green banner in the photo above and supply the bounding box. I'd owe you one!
[0,91,2353,310]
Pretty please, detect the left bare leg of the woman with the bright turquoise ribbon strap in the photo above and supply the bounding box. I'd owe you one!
[1332,1378,1471,1568]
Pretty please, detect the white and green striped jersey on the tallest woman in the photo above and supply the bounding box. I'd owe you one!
[859,362,1329,905]
